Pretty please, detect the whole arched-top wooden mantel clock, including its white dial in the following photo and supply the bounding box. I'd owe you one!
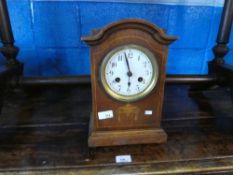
[82,19,176,147]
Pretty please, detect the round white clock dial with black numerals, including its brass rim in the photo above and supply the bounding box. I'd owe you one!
[100,45,159,101]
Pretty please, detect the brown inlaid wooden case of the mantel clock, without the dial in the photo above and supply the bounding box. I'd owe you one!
[82,19,176,147]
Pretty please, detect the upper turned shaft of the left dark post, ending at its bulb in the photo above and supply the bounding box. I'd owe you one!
[0,0,20,68]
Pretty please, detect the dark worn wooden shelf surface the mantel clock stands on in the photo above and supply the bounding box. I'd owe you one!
[0,85,233,175]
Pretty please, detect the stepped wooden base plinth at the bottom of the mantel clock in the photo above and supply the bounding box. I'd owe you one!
[88,128,167,147]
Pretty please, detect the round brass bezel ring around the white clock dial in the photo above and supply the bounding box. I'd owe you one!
[100,44,159,102]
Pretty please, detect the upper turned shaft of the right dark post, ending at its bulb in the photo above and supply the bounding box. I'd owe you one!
[213,0,233,64]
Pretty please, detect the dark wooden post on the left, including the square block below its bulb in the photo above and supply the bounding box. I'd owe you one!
[0,0,23,113]
